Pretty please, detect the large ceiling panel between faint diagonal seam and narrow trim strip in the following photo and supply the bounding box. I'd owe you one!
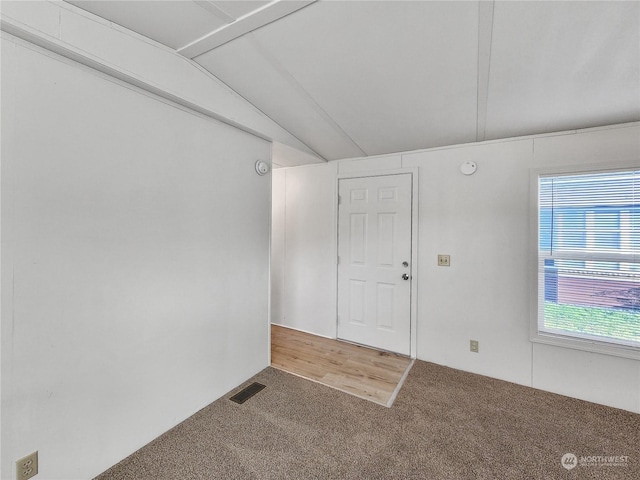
[250,2,478,155]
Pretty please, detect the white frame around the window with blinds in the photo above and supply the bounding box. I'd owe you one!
[529,161,640,360]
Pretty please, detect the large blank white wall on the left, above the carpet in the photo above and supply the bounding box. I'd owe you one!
[0,36,271,480]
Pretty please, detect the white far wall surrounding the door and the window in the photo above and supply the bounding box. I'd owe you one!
[274,124,640,412]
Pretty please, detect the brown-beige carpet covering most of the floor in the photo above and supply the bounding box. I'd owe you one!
[97,361,640,480]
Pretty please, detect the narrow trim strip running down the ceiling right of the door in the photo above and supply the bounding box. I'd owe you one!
[476,0,495,142]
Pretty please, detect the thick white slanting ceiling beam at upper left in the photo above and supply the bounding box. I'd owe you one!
[178,0,317,59]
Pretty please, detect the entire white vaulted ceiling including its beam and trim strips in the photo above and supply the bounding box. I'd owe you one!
[69,0,640,160]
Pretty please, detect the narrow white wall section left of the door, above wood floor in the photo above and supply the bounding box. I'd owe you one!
[271,163,336,337]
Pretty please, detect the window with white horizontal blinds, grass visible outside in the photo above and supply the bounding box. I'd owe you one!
[533,169,640,358]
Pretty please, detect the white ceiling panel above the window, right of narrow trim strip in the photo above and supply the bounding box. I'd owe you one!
[486,2,640,138]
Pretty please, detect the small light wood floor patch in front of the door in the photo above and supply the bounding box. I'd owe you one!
[271,325,413,407]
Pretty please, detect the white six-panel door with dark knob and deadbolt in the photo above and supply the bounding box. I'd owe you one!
[338,174,412,355]
